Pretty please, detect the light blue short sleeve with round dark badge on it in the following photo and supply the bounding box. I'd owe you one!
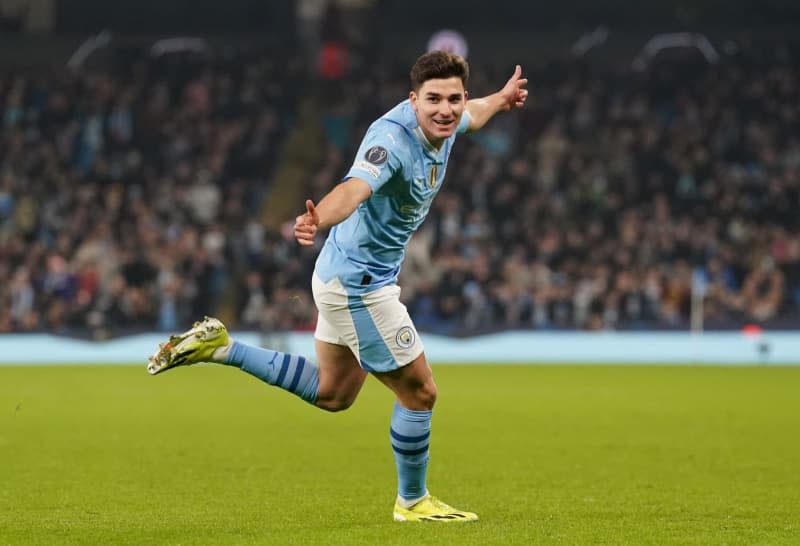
[345,123,402,192]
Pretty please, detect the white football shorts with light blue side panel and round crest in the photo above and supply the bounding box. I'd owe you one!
[311,273,424,372]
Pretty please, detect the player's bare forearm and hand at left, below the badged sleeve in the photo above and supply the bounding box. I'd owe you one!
[294,178,372,246]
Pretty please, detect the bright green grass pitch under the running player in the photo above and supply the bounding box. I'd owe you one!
[0,366,800,545]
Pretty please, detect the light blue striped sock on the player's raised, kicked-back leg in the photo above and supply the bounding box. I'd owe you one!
[225,341,319,404]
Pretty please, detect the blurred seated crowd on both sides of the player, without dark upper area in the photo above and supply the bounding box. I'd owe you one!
[0,36,800,337]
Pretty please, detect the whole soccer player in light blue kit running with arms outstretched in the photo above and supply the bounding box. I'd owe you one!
[148,51,528,522]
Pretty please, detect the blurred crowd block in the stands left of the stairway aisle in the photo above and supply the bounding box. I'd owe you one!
[0,45,302,338]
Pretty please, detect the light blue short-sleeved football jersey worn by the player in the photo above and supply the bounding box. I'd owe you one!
[316,100,469,295]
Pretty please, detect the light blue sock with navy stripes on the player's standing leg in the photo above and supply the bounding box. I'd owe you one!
[389,402,433,500]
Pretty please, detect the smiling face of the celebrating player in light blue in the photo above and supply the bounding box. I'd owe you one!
[409,77,467,147]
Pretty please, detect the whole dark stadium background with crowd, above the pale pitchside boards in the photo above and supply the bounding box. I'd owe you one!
[0,0,800,338]
